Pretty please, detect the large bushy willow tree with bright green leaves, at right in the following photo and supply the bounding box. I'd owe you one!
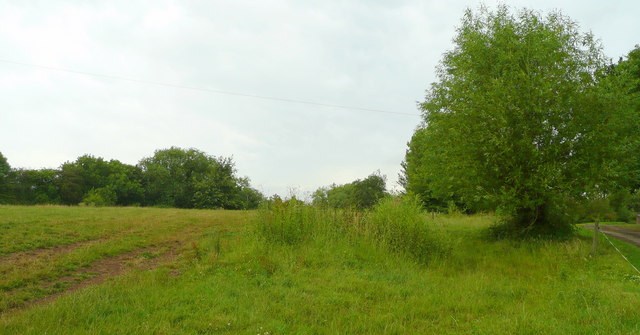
[416,6,632,231]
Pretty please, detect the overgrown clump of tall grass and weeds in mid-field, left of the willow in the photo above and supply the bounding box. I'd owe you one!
[257,196,445,263]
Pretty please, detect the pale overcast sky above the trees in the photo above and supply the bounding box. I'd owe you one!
[0,0,640,196]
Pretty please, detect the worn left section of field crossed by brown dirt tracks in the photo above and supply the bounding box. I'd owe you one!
[0,206,250,312]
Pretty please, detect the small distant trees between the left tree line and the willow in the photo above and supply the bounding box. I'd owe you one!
[311,172,387,209]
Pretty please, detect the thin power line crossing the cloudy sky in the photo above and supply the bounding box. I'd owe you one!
[0,59,420,116]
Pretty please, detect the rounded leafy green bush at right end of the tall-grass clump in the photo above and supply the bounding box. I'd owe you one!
[364,195,444,263]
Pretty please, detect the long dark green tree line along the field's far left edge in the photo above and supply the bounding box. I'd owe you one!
[0,147,263,209]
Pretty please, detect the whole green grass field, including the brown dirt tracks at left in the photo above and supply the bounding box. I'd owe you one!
[0,206,640,334]
